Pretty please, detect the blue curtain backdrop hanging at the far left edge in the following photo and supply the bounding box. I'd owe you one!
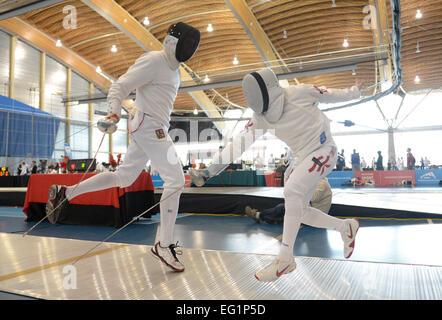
[0,95,60,158]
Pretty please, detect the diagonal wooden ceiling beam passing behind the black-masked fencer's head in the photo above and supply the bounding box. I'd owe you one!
[81,0,225,130]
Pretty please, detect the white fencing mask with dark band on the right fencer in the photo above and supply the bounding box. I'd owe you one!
[242,68,284,123]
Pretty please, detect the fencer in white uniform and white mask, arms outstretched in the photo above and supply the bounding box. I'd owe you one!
[191,68,360,281]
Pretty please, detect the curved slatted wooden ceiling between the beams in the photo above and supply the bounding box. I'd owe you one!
[13,0,442,110]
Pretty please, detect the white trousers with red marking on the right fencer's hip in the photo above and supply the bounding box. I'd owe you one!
[279,145,345,260]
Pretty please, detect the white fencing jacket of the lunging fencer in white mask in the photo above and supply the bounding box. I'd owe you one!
[208,84,360,176]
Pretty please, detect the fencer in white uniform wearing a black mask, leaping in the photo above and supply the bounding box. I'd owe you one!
[46,22,200,272]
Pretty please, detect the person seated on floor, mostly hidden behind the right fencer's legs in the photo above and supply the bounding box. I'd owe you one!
[245,178,332,224]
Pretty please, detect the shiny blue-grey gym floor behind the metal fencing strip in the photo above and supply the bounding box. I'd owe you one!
[0,186,442,299]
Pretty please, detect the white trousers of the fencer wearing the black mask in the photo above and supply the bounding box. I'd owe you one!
[66,112,185,247]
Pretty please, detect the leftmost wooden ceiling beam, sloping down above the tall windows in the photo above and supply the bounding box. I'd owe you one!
[0,18,112,91]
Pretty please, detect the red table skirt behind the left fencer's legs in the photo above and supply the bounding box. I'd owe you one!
[23,171,154,214]
